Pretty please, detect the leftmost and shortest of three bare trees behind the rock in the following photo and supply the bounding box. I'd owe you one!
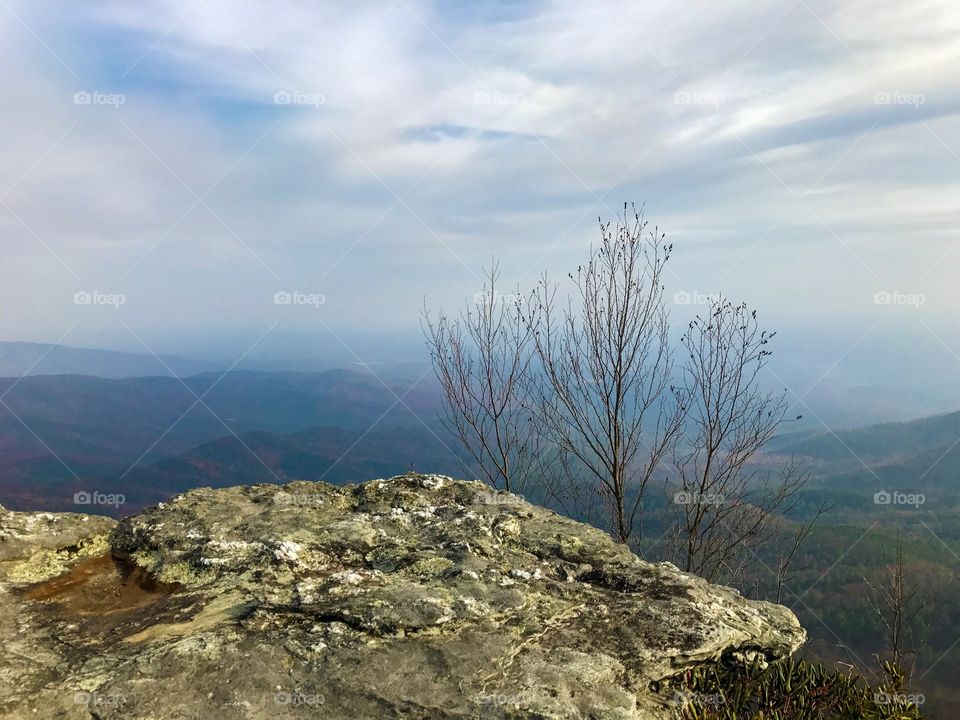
[421,261,542,493]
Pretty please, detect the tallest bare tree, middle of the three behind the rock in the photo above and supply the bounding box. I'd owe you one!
[526,206,680,543]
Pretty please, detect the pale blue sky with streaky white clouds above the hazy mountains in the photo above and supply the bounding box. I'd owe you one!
[0,0,960,422]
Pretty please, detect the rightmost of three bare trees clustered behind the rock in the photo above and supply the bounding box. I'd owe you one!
[667,298,806,580]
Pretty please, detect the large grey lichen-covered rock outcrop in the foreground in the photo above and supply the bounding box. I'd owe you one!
[0,475,804,720]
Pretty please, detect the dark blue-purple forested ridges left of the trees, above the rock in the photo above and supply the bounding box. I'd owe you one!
[0,370,450,510]
